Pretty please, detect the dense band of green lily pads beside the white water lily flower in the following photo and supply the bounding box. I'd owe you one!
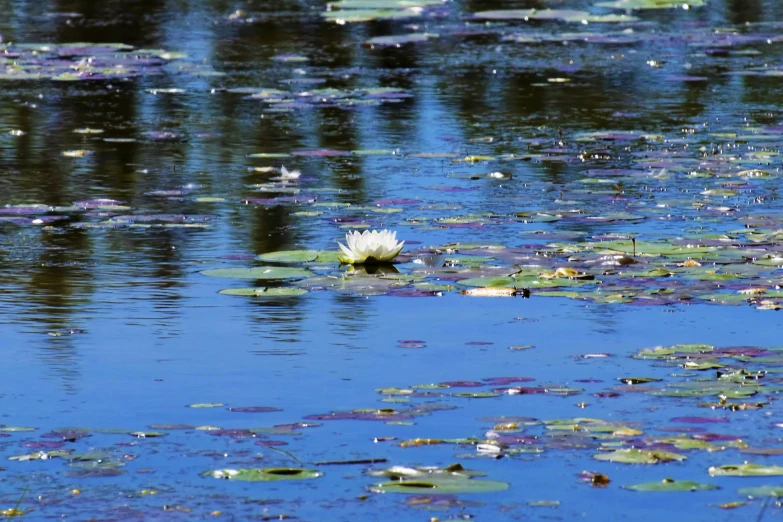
[202,230,783,310]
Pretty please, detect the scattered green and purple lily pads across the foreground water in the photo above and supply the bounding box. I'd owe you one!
[0,344,783,513]
